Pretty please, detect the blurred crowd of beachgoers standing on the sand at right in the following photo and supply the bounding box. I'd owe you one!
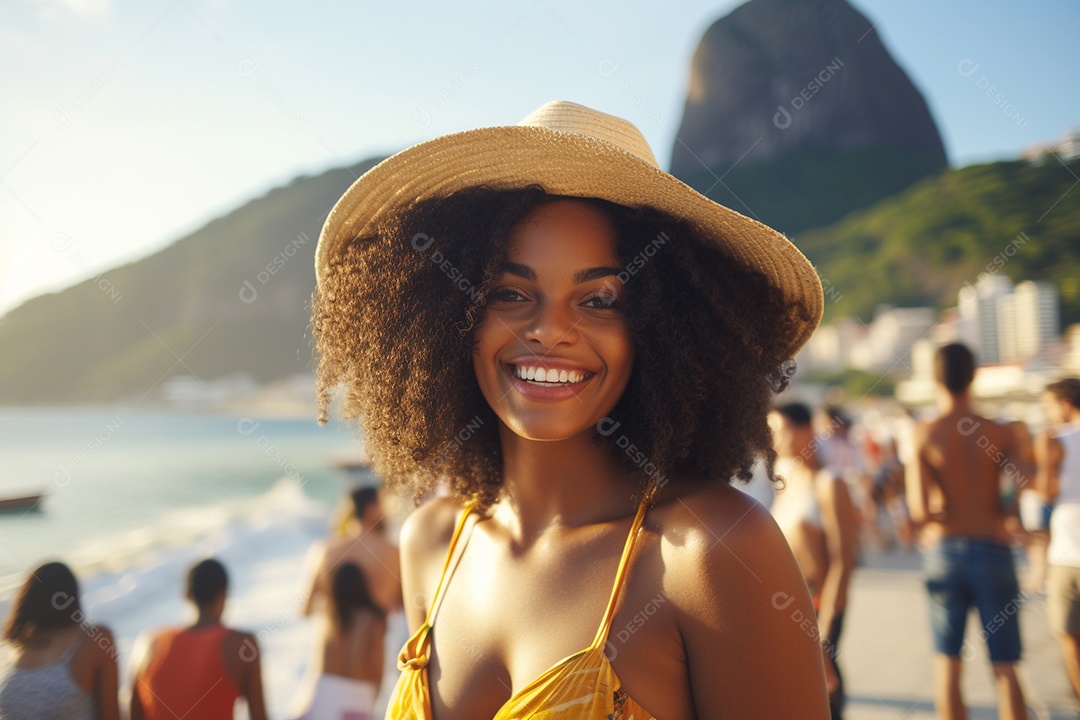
[747,343,1080,720]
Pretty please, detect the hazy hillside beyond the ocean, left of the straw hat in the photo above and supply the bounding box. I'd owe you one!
[0,160,377,404]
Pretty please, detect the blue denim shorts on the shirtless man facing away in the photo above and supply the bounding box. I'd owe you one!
[922,538,1023,663]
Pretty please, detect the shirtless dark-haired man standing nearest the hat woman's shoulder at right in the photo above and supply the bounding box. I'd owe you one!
[769,403,859,720]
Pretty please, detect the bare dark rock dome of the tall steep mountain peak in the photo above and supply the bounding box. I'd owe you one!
[671,0,946,180]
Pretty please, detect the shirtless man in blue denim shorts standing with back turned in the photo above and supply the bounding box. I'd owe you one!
[907,343,1027,720]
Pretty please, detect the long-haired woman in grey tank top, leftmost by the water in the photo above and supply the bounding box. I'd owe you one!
[0,562,120,720]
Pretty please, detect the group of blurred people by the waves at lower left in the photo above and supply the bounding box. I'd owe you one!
[0,488,401,720]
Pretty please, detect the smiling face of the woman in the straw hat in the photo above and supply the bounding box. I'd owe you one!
[473,200,634,440]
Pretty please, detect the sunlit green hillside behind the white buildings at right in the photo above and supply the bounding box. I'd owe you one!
[793,158,1080,324]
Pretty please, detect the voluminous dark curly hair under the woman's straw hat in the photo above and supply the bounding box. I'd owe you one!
[312,186,806,505]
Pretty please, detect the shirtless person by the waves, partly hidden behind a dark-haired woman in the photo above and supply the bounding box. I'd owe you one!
[303,488,402,615]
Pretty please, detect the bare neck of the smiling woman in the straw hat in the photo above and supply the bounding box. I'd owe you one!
[498,425,638,539]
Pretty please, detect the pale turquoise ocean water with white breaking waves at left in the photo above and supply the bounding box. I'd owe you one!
[0,408,384,718]
